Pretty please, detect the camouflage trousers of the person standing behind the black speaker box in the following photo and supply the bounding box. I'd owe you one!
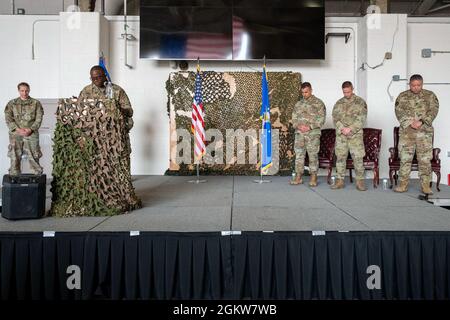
[8,134,43,175]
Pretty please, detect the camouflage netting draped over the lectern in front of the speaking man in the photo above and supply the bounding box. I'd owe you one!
[50,99,141,216]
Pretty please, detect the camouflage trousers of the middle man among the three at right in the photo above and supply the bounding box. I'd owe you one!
[335,132,366,180]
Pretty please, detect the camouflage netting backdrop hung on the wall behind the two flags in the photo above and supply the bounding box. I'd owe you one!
[166,71,300,175]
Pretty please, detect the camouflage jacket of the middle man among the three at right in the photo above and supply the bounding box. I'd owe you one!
[333,94,367,137]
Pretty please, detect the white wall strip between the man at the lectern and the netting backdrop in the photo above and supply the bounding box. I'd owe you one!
[108,17,173,174]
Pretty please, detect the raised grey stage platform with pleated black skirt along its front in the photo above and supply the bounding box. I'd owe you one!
[0,176,450,300]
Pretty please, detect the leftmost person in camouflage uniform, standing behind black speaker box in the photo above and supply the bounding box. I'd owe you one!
[5,82,44,175]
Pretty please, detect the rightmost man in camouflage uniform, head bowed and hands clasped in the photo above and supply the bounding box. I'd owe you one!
[394,74,439,194]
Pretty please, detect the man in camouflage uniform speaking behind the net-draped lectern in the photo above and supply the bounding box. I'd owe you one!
[78,66,133,167]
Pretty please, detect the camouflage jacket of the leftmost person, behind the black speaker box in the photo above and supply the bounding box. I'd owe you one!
[5,97,44,135]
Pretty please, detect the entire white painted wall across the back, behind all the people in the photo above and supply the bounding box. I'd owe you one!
[0,15,450,182]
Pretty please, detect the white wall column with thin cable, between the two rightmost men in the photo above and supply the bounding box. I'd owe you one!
[358,15,408,178]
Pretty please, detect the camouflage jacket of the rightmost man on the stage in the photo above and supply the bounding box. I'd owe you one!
[395,89,439,132]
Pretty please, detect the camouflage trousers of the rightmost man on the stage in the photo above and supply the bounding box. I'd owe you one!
[399,128,433,183]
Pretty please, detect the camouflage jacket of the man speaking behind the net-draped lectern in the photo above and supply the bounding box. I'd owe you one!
[78,83,133,131]
